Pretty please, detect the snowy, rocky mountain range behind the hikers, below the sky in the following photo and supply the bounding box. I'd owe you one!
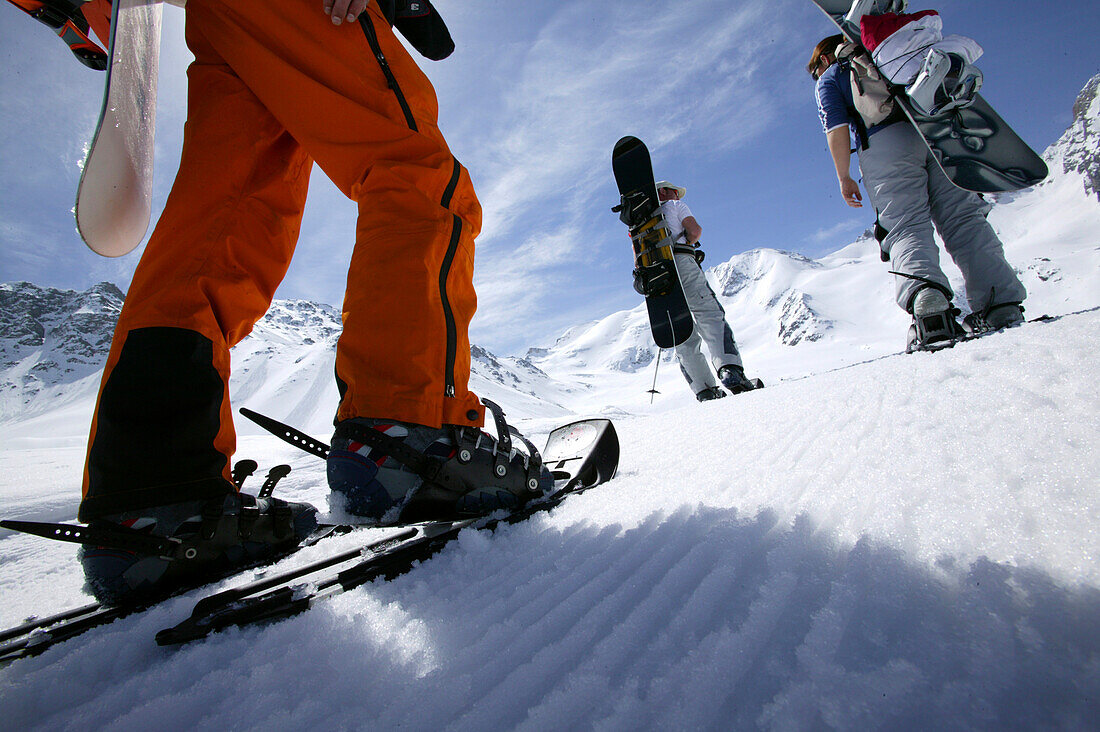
[0,75,1100,434]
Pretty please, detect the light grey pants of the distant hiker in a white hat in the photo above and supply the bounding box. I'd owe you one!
[675,253,741,394]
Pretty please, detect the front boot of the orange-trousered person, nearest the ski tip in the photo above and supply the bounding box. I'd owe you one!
[328,400,553,524]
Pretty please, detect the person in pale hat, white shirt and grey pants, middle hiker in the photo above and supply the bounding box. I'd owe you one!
[657,181,754,402]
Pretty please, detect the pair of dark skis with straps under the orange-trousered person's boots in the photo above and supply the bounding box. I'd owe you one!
[0,409,619,666]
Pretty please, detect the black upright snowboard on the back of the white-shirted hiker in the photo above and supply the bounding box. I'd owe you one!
[612,136,695,348]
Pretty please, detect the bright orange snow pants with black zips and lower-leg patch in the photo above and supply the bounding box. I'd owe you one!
[80,0,484,521]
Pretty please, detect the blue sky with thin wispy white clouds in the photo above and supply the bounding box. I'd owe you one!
[0,0,1100,354]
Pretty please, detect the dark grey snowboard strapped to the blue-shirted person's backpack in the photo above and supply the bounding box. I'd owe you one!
[813,0,1047,193]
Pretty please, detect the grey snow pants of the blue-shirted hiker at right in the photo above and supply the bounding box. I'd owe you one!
[859,122,1027,313]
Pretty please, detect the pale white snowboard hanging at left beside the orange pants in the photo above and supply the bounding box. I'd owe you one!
[76,0,163,256]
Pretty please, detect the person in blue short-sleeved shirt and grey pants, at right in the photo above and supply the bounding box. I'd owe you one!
[807,35,1027,348]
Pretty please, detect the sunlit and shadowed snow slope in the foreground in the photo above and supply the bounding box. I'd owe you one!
[0,309,1100,730]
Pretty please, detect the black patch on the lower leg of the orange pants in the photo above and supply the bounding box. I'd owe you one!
[80,328,233,521]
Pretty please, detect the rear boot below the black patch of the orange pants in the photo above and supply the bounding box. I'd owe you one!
[77,492,317,605]
